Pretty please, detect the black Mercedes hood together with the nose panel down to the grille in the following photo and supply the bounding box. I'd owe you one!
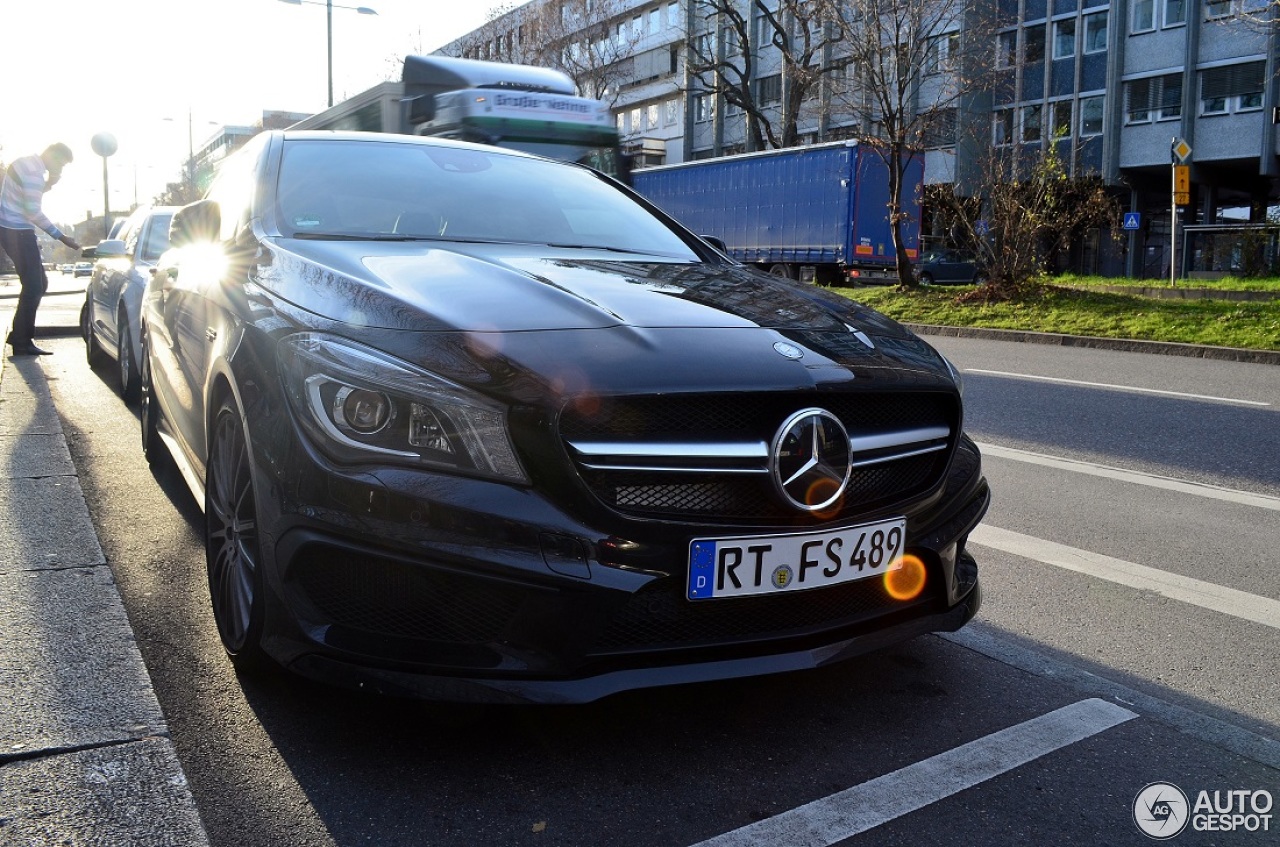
[256,239,954,399]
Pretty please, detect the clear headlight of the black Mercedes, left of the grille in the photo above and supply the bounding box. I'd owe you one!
[278,333,529,482]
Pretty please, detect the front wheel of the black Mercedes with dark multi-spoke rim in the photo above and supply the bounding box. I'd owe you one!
[205,397,266,670]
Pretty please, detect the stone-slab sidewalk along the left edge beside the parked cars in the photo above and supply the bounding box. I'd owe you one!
[0,274,209,847]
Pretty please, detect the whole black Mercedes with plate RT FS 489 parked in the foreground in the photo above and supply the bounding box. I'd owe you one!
[141,131,989,702]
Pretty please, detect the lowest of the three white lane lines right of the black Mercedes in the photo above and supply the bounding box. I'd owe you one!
[969,525,1280,629]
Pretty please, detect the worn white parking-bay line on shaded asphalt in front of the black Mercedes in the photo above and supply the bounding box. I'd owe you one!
[694,699,1138,847]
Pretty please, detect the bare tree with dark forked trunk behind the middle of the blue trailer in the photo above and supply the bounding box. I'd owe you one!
[689,0,841,150]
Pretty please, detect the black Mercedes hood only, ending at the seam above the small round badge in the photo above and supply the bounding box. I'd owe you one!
[259,239,908,338]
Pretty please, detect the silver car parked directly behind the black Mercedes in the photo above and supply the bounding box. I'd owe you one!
[77,206,178,403]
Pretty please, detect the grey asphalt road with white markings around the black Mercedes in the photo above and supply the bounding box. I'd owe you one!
[27,326,1280,847]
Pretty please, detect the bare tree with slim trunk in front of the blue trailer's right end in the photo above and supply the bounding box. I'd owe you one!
[814,0,993,289]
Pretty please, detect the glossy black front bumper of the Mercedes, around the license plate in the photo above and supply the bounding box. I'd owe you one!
[256,417,989,702]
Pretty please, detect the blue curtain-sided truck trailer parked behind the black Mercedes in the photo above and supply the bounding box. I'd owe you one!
[632,141,924,284]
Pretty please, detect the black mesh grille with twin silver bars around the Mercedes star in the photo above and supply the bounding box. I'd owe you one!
[561,393,959,523]
